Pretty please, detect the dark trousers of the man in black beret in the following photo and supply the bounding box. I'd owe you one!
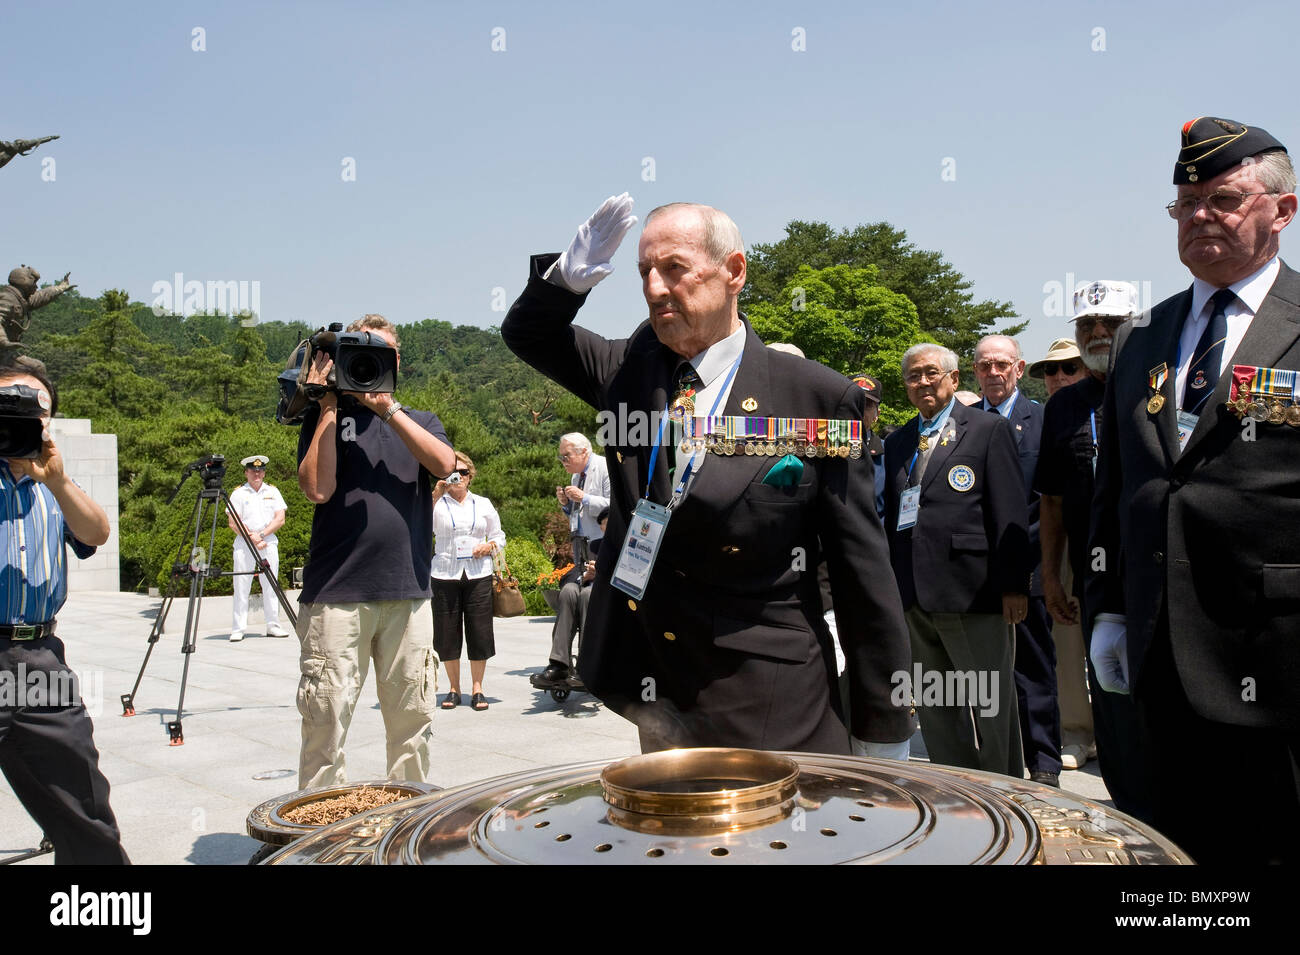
[1136,628,1300,865]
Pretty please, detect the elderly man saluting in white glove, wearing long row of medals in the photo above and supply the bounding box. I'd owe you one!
[502,195,913,756]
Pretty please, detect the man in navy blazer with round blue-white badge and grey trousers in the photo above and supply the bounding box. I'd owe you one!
[885,343,1031,777]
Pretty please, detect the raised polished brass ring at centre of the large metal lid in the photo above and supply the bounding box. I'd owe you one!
[601,748,800,833]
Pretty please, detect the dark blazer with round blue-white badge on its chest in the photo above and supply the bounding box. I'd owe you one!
[885,400,1032,615]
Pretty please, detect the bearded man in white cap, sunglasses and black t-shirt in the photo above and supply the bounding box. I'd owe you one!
[1035,281,1148,817]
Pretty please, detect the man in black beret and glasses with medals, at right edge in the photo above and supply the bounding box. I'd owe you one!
[1086,117,1300,863]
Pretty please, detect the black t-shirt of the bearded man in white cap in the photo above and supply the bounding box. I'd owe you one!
[1034,374,1106,595]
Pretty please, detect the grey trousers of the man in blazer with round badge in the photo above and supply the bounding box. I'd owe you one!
[905,605,1024,778]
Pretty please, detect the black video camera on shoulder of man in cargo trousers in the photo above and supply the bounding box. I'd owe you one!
[276,322,398,425]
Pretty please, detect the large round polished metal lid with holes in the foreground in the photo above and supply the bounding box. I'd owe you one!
[267,750,1188,865]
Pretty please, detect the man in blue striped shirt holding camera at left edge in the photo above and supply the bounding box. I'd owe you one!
[0,356,130,865]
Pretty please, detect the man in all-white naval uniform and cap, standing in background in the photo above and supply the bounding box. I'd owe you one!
[226,455,289,643]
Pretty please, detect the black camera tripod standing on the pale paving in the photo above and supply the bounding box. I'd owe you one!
[121,455,298,746]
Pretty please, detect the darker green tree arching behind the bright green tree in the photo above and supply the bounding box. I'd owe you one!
[741,220,1027,361]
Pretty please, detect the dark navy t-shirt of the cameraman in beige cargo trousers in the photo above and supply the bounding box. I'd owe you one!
[298,395,451,603]
